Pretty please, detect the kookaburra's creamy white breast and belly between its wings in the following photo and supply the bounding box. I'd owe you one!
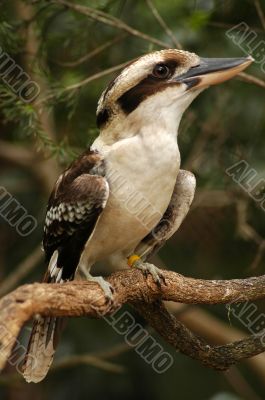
[79,134,180,265]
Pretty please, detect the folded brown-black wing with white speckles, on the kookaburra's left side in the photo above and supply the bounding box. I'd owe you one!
[43,150,109,280]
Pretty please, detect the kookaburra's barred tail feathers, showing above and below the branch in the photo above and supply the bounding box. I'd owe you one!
[22,251,64,383]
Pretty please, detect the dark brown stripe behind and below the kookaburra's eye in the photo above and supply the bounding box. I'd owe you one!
[117,60,178,114]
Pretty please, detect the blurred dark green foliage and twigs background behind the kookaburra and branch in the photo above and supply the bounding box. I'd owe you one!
[0,0,265,400]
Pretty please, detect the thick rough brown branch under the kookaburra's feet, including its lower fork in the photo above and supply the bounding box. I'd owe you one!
[0,270,265,376]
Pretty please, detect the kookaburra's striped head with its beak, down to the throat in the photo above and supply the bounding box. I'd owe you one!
[97,49,253,142]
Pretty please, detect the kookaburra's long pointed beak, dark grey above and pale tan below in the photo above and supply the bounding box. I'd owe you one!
[175,56,254,89]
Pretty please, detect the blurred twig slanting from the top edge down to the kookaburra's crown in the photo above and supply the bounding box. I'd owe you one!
[52,0,170,48]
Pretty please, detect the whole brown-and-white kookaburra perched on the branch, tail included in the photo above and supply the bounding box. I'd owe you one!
[23,49,253,382]
